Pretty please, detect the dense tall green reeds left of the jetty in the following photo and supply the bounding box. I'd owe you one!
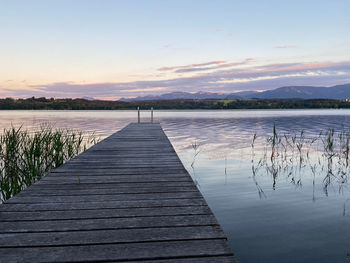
[0,126,97,201]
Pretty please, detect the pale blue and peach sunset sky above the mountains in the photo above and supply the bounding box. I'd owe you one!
[0,0,350,100]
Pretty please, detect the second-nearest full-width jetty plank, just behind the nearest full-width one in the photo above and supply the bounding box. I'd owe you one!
[0,226,225,248]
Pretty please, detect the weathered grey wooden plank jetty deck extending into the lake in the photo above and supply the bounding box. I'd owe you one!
[0,123,235,263]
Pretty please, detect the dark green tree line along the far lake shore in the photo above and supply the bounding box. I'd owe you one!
[0,97,350,110]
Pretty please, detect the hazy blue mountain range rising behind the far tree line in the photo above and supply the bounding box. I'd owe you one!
[120,83,350,101]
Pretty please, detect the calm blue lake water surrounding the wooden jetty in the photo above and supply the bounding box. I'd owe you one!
[0,110,350,263]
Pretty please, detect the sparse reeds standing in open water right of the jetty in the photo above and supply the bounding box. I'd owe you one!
[251,124,350,200]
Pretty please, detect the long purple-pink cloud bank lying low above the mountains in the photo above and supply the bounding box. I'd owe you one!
[1,61,350,99]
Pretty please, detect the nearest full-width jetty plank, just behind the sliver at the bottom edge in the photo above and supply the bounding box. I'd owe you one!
[0,239,232,262]
